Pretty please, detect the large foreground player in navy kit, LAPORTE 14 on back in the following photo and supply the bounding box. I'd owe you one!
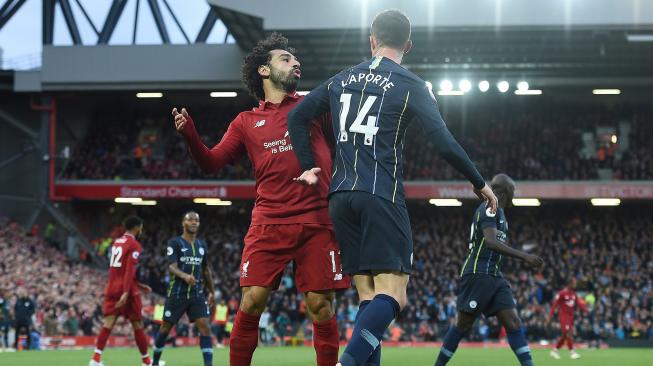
[288,10,496,366]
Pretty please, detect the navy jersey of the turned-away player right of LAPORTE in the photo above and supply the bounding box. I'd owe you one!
[460,202,508,277]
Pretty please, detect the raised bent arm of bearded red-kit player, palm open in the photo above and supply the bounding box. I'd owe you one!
[172,108,244,173]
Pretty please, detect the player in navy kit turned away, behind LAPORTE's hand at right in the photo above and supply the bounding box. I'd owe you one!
[435,174,544,366]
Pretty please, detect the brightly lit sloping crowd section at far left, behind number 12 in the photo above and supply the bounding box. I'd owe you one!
[0,218,157,347]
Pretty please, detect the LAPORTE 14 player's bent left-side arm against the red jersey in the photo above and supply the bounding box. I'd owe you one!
[288,80,329,185]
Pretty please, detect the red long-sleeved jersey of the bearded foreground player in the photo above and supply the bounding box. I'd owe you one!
[182,93,333,225]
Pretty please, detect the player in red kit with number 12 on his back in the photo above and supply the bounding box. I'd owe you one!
[89,216,157,366]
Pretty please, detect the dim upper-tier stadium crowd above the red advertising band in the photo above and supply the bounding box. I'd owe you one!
[63,104,653,180]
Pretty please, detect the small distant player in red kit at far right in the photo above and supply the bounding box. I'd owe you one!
[549,279,588,360]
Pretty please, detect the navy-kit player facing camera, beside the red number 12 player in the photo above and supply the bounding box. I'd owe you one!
[152,211,215,366]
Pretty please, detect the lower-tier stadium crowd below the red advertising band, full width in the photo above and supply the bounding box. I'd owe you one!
[0,203,653,343]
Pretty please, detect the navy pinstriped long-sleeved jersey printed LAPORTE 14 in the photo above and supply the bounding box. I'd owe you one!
[288,57,485,206]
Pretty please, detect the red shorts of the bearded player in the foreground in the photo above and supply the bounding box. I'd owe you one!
[240,224,350,293]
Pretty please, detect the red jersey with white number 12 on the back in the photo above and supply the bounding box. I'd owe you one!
[104,233,143,296]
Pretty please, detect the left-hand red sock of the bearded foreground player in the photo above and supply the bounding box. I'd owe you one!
[229,309,260,366]
